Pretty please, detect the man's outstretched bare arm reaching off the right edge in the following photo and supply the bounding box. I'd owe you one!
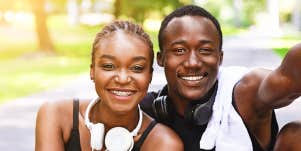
[258,43,301,108]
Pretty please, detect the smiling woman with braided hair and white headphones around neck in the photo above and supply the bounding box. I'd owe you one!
[35,21,183,151]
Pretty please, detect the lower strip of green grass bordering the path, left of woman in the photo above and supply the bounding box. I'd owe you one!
[0,57,89,103]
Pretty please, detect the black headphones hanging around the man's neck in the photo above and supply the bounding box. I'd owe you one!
[152,81,218,125]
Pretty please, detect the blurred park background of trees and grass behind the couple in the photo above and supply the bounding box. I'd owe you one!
[0,0,301,104]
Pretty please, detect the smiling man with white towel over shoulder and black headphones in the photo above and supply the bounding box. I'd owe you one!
[141,5,301,151]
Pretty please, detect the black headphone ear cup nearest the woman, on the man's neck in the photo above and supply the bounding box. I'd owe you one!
[152,95,170,122]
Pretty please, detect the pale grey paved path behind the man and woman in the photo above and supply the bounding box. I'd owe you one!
[0,31,301,151]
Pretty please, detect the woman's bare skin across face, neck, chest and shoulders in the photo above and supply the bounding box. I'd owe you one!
[35,31,183,151]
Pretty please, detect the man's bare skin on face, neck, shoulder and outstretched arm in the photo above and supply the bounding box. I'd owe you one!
[157,16,301,149]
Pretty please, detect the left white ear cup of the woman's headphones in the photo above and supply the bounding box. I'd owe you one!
[90,123,105,150]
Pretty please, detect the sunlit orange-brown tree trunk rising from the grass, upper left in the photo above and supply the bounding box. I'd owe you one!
[32,0,54,53]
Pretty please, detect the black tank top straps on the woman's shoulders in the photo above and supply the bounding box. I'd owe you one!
[65,99,157,151]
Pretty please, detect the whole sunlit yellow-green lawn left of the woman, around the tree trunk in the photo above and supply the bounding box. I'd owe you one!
[0,16,97,103]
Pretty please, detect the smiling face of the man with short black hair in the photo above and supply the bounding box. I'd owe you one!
[157,16,223,104]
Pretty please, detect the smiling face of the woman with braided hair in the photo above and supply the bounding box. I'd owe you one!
[90,30,152,112]
